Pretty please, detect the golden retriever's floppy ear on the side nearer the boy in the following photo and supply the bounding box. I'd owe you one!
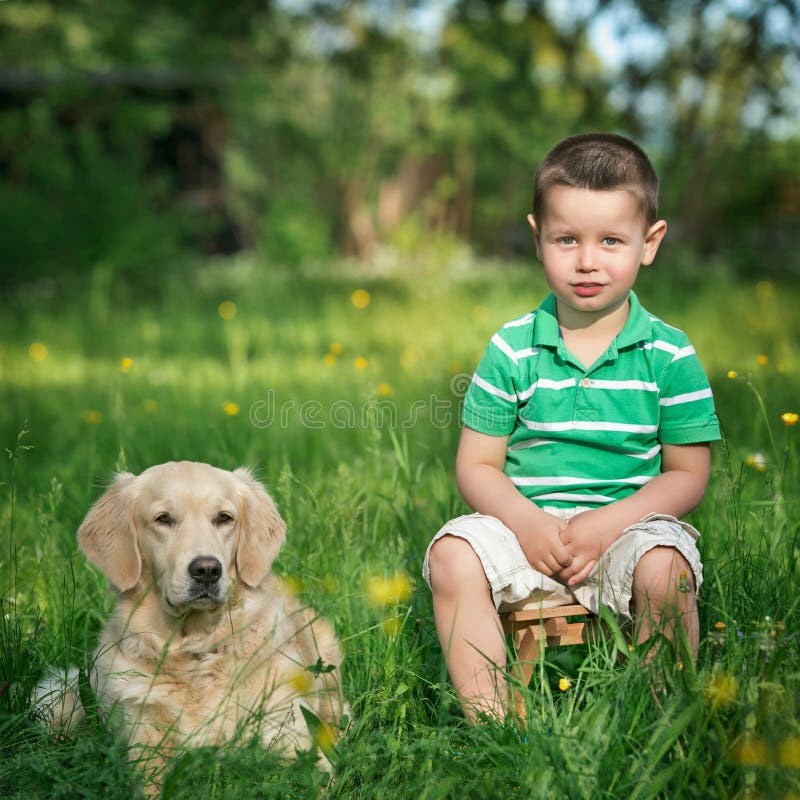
[233,467,286,587]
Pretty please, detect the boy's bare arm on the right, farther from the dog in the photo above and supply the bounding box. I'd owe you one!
[558,442,711,586]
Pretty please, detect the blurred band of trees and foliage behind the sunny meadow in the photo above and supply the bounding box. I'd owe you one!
[0,0,800,285]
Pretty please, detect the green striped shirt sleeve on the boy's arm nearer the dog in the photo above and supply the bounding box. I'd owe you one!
[461,331,518,436]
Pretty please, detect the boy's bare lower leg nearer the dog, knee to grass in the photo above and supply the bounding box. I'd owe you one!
[428,536,507,721]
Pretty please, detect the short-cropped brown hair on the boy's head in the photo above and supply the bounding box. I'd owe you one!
[533,133,658,227]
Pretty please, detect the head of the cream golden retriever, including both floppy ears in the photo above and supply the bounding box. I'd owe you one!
[78,461,286,616]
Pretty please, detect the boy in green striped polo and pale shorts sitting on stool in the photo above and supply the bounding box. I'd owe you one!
[423,134,719,720]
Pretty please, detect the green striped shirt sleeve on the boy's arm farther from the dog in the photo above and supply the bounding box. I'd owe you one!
[658,339,721,444]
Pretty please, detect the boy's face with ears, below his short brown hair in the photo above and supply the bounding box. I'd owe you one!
[528,185,667,324]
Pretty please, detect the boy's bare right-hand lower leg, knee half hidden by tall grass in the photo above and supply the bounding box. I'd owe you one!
[633,547,700,659]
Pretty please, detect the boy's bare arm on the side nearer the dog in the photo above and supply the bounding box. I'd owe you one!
[456,427,572,575]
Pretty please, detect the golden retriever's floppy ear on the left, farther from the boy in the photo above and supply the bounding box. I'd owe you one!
[78,472,142,592]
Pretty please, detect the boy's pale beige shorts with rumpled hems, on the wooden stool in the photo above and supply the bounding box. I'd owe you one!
[422,507,703,618]
